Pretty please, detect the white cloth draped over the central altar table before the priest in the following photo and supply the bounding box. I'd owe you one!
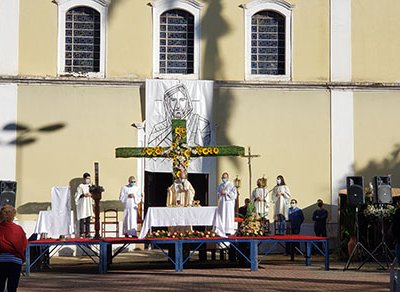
[139,207,226,238]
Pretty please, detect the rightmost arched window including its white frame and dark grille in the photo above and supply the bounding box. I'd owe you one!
[243,0,293,80]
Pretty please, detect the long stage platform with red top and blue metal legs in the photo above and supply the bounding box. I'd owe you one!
[25,235,329,276]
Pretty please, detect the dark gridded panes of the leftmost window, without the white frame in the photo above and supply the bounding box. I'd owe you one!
[65,6,100,73]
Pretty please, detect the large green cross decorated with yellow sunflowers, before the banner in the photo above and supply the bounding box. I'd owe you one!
[115,120,244,178]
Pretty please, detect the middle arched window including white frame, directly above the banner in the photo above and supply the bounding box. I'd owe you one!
[152,0,200,79]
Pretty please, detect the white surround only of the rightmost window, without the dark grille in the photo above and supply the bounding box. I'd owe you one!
[242,0,294,81]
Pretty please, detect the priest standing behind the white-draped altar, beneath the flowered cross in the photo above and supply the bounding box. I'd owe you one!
[167,171,195,207]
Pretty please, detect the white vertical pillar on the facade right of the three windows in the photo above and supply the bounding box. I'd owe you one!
[330,0,354,222]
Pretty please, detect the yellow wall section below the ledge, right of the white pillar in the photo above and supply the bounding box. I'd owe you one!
[354,91,400,187]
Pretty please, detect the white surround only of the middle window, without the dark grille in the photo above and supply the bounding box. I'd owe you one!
[152,0,201,79]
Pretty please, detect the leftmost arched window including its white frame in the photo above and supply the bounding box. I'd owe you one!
[55,0,110,77]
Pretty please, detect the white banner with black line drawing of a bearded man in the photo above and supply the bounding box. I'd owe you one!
[145,80,215,173]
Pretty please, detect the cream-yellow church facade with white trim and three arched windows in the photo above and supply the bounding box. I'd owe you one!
[0,0,400,234]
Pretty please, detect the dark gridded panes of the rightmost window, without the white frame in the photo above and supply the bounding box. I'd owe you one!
[251,10,286,75]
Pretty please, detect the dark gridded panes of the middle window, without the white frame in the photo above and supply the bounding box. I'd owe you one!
[159,9,194,74]
